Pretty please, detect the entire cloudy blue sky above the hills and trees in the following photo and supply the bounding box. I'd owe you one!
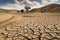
[0,0,60,10]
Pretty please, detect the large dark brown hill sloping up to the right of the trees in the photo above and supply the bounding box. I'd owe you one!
[29,4,60,13]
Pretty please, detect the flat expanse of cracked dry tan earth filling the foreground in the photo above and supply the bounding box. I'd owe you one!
[0,13,60,40]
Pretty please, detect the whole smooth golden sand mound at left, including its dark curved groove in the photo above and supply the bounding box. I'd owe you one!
[0,13,22,26]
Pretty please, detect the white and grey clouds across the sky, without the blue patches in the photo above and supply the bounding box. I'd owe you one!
[1,0,58,10]
